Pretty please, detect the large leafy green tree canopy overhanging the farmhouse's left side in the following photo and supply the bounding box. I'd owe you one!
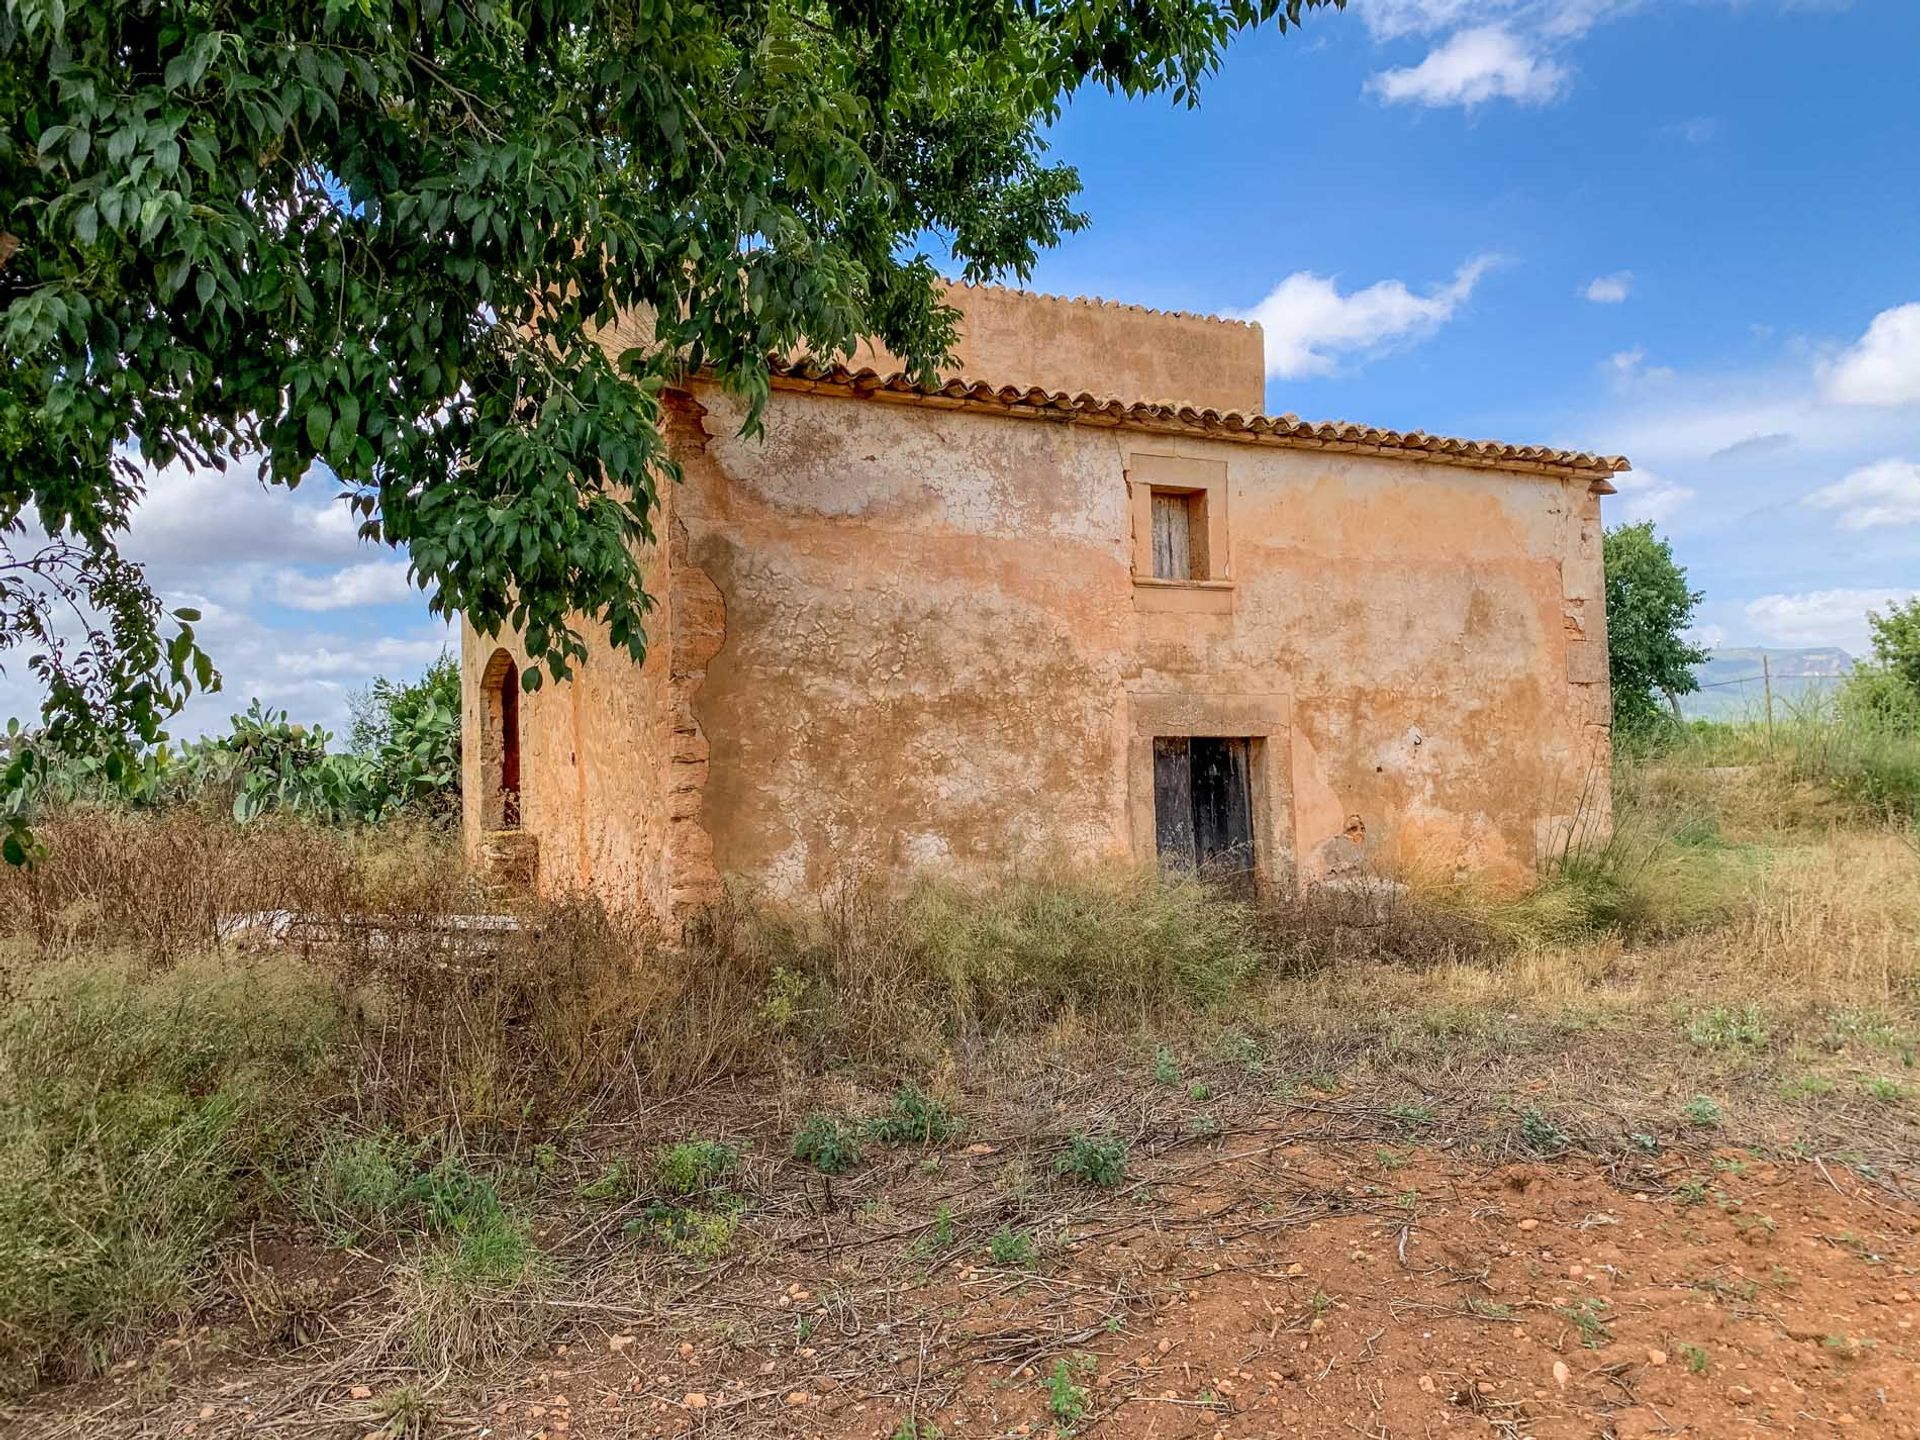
[0,0,1344,856]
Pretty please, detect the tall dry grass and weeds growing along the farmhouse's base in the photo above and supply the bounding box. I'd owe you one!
[0,744,1920,1413]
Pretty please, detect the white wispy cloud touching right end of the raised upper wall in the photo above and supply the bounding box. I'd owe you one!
[1238,255,1498,380]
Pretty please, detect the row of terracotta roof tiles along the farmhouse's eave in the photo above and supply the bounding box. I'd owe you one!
[756,357,1632,493]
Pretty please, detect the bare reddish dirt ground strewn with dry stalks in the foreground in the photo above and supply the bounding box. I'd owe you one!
[30,1094,1920,1440]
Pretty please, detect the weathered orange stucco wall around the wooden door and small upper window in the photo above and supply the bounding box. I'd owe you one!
[656,390,1607,906]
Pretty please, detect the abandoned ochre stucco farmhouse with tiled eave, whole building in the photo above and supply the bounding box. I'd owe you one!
[463,286,1626,924]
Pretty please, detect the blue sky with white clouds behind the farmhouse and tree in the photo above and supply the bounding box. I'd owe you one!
[0,0,1920,733]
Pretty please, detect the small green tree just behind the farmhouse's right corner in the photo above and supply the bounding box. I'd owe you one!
[1603,520,1709,735]
